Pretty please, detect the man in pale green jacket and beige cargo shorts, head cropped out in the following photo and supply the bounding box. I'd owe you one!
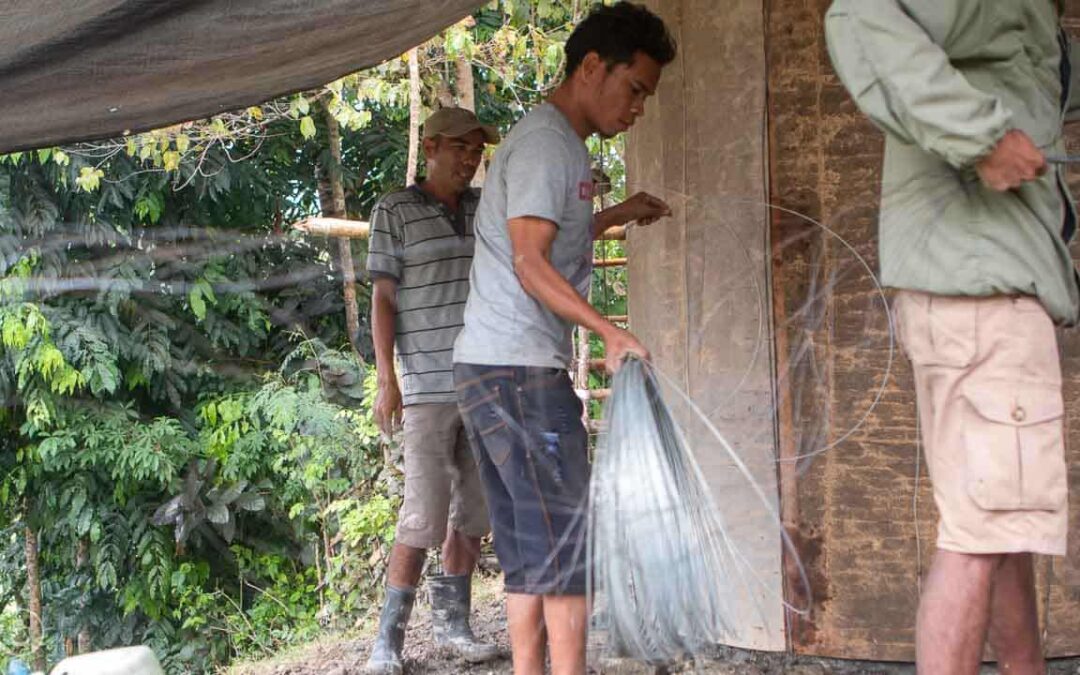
[825,0,1080,675]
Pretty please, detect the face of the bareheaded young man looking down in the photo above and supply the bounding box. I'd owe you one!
[582,52,661,138]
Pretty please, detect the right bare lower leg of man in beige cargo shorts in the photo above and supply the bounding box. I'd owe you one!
[990,553,1047,675]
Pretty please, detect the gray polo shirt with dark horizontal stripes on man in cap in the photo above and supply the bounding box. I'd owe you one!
[367,185,480,405]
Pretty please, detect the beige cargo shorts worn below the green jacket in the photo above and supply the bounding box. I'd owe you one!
[893,291,1068,555]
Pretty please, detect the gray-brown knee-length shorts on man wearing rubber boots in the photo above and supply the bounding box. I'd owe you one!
[397,402,490,549]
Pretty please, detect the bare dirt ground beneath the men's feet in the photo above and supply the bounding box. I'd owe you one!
[226,577,1080,675]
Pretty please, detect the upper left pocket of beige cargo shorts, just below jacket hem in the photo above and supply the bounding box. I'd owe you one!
[893,291,978,368]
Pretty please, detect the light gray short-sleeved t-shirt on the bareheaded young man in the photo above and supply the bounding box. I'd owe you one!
[454,104,593,368]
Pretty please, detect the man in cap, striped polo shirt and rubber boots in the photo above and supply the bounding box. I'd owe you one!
[366,108,499,674]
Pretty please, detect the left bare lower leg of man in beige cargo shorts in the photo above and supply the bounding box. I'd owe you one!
[915,550,1002,675]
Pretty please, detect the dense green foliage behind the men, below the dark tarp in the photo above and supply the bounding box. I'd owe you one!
[0,0,625,673]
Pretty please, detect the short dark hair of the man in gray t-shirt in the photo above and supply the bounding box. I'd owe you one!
[566,2,675,78]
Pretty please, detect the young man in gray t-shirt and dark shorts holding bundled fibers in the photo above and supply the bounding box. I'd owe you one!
[454,2,675,674]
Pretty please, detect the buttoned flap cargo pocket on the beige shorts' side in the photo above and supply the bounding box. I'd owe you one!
[963,380,1068,511]
